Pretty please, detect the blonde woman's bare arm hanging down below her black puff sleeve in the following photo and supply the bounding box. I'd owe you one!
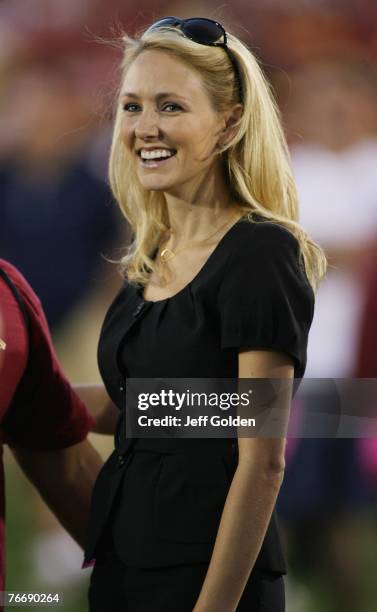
[194,351,293,612]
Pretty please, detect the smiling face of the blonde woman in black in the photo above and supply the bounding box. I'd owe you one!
[120,50,225,198]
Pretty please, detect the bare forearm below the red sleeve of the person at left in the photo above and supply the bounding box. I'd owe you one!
[12,440,102,547]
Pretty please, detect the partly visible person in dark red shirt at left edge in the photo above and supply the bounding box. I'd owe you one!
[0,259,102,611]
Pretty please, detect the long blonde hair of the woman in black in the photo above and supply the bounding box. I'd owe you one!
[109,27,326,291]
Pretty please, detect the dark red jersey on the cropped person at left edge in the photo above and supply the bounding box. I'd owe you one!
[0,259,94,611]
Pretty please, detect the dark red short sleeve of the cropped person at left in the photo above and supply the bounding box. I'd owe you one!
[1,262,94,450]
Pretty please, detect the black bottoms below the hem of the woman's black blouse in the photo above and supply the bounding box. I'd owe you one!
[89,550,285,612]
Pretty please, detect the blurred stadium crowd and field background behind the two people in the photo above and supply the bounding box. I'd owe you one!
[0,0,377,612]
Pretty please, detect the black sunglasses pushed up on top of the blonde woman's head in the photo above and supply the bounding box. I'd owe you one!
[144,17,243,100]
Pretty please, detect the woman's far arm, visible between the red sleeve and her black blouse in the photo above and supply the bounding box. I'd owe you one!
[73,384,119,435]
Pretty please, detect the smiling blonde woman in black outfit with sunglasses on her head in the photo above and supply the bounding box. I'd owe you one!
[86,17,326,612]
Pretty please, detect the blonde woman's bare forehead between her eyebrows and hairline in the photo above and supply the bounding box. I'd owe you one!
[121,49,207,99]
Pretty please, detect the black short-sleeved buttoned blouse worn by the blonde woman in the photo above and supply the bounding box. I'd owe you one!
[86,216,314,573]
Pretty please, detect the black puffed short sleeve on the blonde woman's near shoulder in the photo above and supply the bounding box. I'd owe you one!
[218,222,314,378]
